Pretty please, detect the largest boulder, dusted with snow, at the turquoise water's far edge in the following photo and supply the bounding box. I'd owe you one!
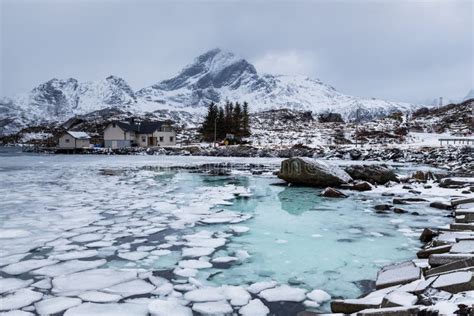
[278,157,352,187]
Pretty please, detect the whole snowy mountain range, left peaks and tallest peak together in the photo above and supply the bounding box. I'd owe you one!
[0,49,456,134]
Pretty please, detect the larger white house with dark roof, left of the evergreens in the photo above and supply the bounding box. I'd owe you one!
[104,121,176,148]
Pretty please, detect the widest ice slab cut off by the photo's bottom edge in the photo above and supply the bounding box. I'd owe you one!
[64,303,148,316]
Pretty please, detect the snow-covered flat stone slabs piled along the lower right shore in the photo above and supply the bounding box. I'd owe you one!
[331,181,474,316]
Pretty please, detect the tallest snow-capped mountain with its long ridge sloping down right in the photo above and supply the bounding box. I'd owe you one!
[137,49,416,119]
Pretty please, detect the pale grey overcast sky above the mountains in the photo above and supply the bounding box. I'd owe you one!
[0,0,474,102]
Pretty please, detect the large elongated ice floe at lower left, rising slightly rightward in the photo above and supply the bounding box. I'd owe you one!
[53,269,137,293]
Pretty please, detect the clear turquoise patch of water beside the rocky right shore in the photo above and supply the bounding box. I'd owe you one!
[158,173,449,297]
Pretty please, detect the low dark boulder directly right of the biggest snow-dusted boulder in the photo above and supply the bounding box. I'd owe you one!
[344,165,398,184]
